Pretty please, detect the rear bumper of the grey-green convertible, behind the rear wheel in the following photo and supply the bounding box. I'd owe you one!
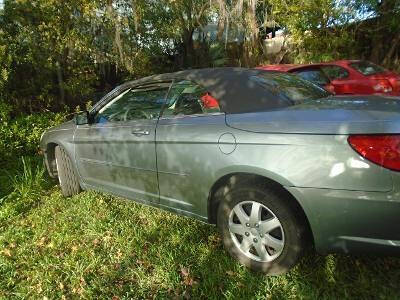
[287,187,400,255]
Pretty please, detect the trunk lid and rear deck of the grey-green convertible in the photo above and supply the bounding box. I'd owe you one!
[226,96,400,134]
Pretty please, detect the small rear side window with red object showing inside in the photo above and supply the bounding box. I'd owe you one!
[162,80,220,117]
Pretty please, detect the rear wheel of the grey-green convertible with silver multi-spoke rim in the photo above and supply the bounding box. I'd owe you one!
[217,181,306,275]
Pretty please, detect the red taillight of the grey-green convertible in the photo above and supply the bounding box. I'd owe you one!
[348,134,400,171]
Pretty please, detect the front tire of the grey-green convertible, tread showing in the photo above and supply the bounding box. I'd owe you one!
[55,146,82,197]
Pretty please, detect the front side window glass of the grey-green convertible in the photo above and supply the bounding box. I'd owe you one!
[95,83,170,123]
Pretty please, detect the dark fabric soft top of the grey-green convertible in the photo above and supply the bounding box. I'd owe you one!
[124,68,288,114]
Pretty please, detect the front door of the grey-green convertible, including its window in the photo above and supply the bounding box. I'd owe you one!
[74,82,170,202]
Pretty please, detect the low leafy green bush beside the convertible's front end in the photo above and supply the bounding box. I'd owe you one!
[0,106,65,162]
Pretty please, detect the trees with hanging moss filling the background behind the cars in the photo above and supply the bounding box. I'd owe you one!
[0,0,400,113]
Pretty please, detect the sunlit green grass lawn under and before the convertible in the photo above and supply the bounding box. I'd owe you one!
[0,160,400,299]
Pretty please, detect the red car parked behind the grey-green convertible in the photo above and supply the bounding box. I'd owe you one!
[258,60,400,96]
